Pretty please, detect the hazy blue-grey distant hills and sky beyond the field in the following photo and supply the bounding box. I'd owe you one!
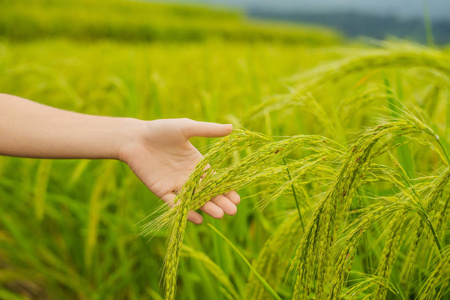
[178,0,450,44]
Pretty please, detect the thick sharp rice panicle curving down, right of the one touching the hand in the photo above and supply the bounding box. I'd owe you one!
[291,114,440,299]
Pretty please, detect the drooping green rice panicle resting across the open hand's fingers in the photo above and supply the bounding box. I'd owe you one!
[143,131,342,299]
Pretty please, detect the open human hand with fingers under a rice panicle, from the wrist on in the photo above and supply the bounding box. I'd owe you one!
[119,119,240,224]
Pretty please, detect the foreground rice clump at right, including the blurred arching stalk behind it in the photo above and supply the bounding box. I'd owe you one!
[130,38,450,299]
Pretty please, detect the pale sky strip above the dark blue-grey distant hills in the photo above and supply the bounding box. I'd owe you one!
[164,0,450,19]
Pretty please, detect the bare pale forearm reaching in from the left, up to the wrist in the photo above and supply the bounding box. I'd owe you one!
[0,94,141,159]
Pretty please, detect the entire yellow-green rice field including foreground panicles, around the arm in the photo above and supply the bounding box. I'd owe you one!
[0,0,450,300]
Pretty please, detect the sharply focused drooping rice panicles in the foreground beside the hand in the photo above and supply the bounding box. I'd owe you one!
[144,111,448,299]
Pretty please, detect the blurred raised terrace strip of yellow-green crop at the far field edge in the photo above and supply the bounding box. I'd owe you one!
[0,0,341,45]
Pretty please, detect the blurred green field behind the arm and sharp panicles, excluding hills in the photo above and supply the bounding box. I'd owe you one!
[0,0,450,299]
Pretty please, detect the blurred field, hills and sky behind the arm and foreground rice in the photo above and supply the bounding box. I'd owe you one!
[0,0,450,300]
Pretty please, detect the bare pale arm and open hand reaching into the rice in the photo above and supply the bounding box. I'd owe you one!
[0,94,240,224]
